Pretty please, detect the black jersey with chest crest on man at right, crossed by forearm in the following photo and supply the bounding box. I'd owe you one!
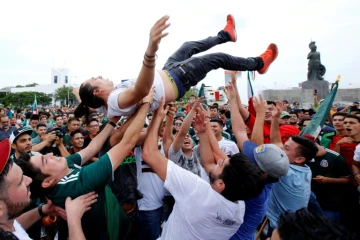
[307,149,351,211]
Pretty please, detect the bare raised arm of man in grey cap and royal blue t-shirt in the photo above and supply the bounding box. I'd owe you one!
[225,83,249,150]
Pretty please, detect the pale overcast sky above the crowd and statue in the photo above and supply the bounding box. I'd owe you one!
[0,0,360,95]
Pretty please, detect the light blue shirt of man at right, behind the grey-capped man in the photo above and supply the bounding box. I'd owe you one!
[266,164,312,228]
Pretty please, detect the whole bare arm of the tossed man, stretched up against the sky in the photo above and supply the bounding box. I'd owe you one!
[118,16,170,108]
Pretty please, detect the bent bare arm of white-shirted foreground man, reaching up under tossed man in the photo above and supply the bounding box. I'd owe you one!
[142,97,170,181]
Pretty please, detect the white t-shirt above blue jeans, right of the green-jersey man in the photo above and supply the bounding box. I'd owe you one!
[134,147,164,211]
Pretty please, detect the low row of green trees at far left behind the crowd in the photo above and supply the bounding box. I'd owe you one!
[0,92,51,107]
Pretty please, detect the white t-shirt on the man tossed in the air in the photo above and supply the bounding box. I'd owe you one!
[105,71,165,118]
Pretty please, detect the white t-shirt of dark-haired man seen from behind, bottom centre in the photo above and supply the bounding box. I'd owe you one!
[159,161,245,240]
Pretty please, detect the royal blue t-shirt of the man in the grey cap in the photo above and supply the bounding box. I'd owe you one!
[230,141,273,240]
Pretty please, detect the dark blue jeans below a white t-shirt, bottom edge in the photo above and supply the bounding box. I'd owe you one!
[137,207,163,240]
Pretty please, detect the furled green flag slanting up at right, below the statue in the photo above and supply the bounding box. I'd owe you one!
[300,76,340,138]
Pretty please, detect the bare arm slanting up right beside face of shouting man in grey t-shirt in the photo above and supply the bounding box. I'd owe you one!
[172,98,203,152]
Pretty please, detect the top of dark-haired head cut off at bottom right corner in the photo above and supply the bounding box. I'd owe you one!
[277,208,357,240]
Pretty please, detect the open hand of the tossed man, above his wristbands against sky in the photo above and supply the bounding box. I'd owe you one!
[146,15,170,57]
